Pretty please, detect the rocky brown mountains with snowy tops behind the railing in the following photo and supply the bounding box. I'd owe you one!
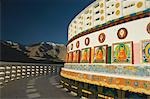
[0,41,66,63]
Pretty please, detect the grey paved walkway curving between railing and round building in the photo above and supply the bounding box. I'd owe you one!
[0,75,78,99]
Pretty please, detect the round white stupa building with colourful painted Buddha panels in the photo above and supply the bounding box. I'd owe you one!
[61,0,150,99]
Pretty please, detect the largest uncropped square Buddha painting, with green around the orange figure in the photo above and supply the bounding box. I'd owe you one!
[113,42,132,63]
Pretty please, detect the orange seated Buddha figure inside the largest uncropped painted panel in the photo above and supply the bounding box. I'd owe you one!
[117,44,127,61]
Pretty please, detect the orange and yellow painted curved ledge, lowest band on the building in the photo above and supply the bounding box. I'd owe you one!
[61,68,150,95]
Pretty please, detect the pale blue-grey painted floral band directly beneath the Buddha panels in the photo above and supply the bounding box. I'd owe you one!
[65,63,150,78]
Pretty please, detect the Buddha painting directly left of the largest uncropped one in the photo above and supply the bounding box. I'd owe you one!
[94,46,107,63]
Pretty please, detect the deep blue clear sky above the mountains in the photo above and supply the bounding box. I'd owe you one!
[1,0,94,44]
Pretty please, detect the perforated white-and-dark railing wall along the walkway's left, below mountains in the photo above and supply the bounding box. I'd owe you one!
[0,62,64,85]
